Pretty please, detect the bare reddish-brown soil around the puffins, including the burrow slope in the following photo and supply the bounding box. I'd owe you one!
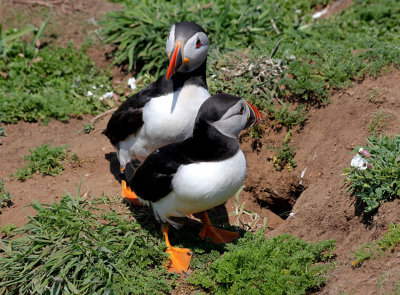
[0,0,400,294]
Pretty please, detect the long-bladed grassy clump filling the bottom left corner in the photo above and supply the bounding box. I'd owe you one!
[0,190,174,295]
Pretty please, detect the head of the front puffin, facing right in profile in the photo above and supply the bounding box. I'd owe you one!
[196,93,262,138]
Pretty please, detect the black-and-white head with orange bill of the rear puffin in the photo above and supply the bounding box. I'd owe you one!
[166,22,209,80]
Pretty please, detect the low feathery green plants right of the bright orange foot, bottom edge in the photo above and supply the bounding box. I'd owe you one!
[188,232,335,294]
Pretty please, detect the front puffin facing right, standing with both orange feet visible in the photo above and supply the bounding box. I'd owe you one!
[124,93,261,274]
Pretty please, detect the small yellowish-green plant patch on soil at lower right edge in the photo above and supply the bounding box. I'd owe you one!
[351,223,400,267]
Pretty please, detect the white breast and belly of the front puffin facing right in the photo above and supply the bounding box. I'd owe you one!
[152,150,246,225]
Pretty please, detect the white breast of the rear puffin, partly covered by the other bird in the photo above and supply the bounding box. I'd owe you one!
[118,85,210,166]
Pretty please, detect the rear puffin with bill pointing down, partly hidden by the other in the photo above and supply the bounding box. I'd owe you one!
[103,22,210,205]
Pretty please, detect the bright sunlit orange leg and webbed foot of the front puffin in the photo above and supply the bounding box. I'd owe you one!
[161,224,192,274]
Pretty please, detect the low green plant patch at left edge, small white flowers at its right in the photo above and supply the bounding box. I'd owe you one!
[0,27,111,123]
